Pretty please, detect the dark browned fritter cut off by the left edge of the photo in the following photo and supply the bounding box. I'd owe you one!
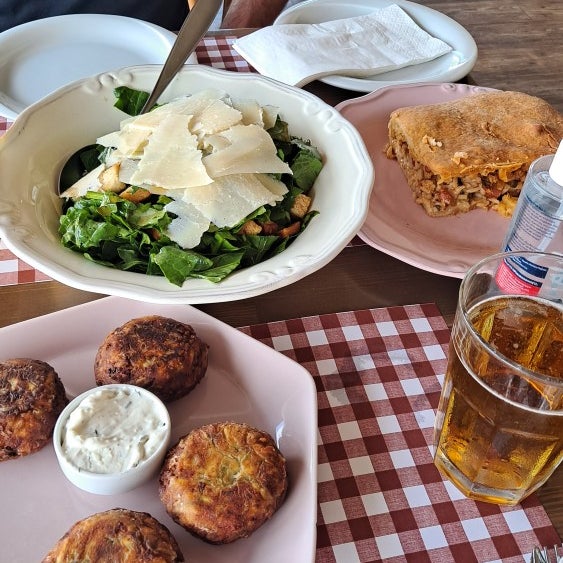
[0,358,68,461]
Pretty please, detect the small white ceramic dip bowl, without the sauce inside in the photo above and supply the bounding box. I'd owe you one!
[53,383,171,495]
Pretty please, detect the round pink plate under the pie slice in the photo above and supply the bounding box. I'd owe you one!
[337,83,510,278]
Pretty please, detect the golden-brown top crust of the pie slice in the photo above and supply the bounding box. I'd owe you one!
[389,91,563,181]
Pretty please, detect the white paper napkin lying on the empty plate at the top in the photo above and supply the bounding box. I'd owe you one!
[233,4,452,86]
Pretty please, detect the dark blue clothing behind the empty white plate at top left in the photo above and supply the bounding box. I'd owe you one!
[0,0,188,32]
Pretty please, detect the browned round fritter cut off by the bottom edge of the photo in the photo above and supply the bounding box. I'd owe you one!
[42,508,184,563]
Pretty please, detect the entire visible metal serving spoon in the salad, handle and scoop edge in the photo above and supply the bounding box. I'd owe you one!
[58,0,223,194]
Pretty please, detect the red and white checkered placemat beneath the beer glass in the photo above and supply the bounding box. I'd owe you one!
[241,304,560,563]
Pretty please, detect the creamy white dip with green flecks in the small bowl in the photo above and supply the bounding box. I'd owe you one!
[61,388,166,473]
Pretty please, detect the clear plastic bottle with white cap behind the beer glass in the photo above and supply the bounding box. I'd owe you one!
[497,141,563,299]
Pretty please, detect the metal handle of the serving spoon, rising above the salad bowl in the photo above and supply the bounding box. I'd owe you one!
[141,0,223,113]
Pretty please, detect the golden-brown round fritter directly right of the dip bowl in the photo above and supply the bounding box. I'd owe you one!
[160,422,287,544]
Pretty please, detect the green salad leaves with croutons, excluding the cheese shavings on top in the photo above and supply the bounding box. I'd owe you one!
[59,87,322,286]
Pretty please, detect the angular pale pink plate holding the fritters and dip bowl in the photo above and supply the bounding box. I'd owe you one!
[0,297,317,563]
